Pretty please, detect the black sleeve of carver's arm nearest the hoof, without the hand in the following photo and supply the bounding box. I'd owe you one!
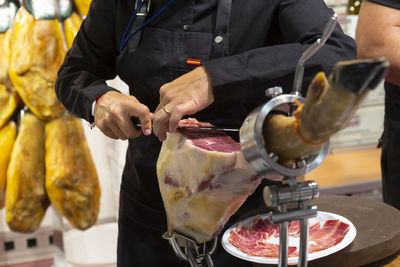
[205,0,356,98]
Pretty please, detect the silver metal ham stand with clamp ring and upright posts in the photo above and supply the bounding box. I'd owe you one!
[240,15,337,267]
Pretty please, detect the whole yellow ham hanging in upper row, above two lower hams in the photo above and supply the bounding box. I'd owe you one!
[8,7,66,120]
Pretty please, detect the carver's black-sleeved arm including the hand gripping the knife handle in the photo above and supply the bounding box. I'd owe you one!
[56,0,152,140]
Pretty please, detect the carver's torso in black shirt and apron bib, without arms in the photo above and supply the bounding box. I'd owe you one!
[116,0,279,112]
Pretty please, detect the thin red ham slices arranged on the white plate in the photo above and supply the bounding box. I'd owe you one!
[228,216,350,258]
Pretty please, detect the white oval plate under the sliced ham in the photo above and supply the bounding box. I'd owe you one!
[221,211,357,264]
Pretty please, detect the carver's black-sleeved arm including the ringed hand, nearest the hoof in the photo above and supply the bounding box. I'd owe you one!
[154,0,356,140]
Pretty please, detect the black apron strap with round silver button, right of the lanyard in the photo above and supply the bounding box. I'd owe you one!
[212,0,232,57]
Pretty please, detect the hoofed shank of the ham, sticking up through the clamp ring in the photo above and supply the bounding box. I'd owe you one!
[263,59,389,165]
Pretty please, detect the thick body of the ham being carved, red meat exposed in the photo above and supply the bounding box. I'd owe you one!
[157,119,261,243]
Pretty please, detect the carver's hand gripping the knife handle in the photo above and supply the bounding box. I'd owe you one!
[94,91,153,140]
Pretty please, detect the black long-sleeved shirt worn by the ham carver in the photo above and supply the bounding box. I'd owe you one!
[56,0,356,122]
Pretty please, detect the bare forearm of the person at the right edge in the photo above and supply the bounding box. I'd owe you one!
[356,1,400,85]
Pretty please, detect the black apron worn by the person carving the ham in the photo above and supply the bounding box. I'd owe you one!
[117,0,276,267]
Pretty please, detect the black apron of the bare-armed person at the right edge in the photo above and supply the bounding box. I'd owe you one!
[381,82,400,210]
